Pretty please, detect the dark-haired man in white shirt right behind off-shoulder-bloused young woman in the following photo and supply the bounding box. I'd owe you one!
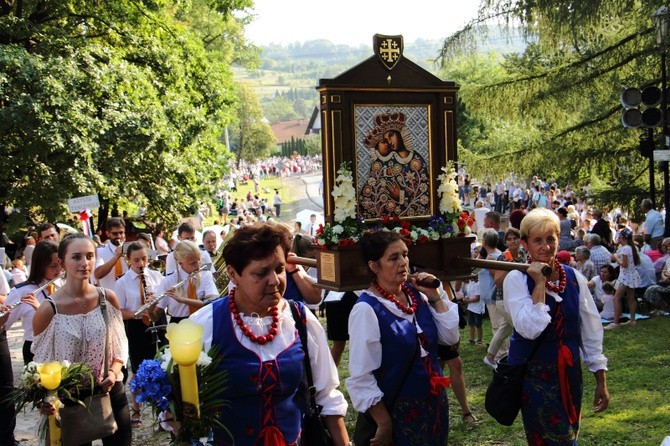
[93,217,128,290]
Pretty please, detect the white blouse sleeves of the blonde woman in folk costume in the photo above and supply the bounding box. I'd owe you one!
[503,271,607,373]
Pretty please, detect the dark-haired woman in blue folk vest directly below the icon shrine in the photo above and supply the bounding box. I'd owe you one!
[346,231,459,446]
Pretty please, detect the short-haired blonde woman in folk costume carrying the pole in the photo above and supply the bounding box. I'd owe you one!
[503,208,609,446]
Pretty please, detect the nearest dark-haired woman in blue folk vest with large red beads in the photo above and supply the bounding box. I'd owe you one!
[191,224,349,446]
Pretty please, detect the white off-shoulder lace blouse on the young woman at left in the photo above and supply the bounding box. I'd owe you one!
[31,292,128,381]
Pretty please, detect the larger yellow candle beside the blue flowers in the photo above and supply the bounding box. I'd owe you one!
[166,319,203,416]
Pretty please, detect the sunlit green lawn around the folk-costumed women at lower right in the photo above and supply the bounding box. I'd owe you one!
[332,317,670,446]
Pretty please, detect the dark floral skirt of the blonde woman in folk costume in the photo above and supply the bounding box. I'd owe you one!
[521,361,583,446]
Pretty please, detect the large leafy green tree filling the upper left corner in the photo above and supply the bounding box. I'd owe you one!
[0,0,254,228]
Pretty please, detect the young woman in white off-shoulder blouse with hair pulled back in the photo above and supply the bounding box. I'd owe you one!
[32,233,132,446]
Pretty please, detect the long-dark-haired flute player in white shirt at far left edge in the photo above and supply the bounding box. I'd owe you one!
[0,239,63,364]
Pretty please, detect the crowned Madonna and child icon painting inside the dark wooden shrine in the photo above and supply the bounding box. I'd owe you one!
[354,105,434,220]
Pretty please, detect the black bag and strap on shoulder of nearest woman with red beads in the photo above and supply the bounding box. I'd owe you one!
[289,300,334,446]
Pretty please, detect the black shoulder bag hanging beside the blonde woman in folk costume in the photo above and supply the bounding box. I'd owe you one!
[484,302,560,426]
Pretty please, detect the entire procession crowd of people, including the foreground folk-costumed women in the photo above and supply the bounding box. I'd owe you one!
[0,166,670,446]
